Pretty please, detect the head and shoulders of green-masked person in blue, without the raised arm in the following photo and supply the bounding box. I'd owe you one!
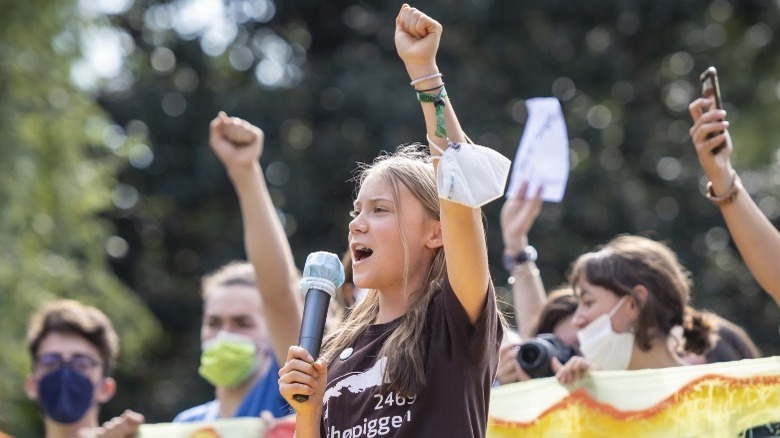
[173,262,290,422]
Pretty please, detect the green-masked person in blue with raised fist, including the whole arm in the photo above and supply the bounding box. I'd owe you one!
[173,113,303,422]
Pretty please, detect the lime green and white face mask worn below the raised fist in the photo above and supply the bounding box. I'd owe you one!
[198,332,257,388]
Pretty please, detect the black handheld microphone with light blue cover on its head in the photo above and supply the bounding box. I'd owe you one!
[293,251,344,402]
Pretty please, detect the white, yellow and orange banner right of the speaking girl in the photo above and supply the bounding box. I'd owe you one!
[488,357,780,438]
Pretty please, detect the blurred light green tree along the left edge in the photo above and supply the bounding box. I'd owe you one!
[0,0,159,436]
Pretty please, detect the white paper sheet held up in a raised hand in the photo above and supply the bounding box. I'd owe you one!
[506,97,569,202]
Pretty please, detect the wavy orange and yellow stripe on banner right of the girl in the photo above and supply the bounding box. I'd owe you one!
[488,374,780,438]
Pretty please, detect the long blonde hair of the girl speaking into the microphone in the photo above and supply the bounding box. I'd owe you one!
[322,144,447,396]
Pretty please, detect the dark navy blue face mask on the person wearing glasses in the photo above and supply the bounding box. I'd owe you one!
[38,366,95,424]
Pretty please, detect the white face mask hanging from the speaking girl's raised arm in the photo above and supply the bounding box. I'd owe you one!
[428,138,512,208]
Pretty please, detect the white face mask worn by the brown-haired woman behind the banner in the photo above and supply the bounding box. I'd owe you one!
[577,295,634,370]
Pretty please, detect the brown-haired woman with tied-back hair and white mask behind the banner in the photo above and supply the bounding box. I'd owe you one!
[553,235,715,383]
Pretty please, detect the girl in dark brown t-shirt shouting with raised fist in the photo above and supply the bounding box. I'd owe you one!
[279,5,509,438]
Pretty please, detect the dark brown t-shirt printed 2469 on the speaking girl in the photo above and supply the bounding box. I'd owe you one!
[321,280,502,438]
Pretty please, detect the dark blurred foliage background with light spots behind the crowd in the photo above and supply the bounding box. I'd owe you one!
[0,0,780,436]
